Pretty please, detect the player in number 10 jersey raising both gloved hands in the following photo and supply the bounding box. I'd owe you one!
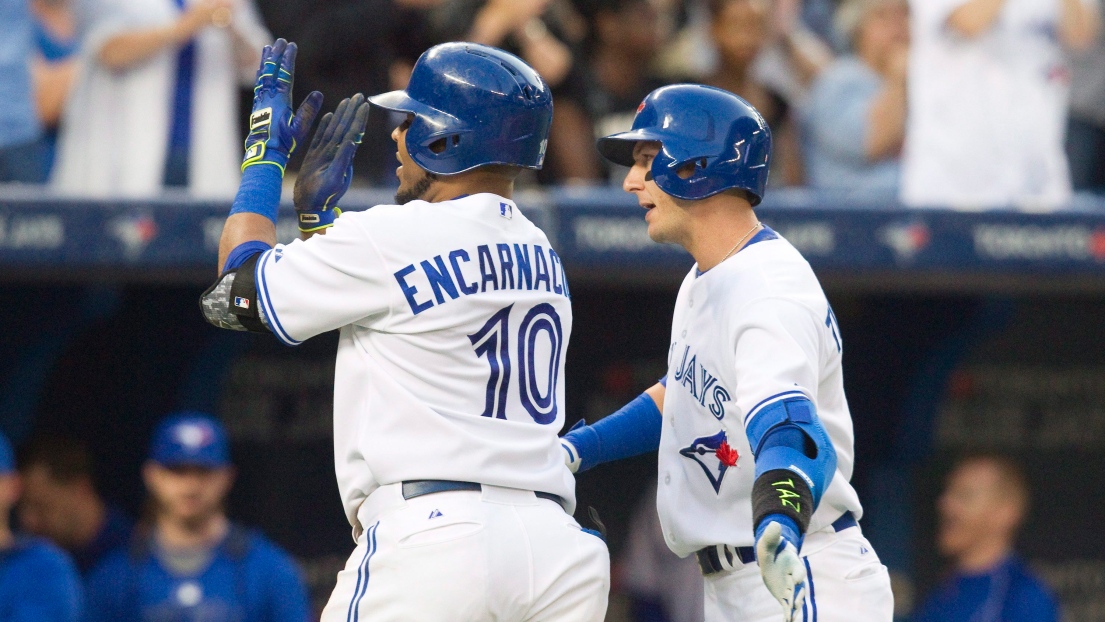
[202,40,610,622]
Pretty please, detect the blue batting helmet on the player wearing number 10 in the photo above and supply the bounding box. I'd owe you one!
[368,43,553,175]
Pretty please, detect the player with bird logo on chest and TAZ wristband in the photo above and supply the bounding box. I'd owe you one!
[564,84,893,622]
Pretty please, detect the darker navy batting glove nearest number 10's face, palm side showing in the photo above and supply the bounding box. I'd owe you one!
[293,93,369,233]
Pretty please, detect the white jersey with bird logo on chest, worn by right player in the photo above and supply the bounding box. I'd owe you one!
[656,229,862,557]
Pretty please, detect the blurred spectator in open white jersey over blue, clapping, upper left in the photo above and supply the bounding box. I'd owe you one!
[52,0,272,198]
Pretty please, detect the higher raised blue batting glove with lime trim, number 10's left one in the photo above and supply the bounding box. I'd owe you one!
[242,39,323,175]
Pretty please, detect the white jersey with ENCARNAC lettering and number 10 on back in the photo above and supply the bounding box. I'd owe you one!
[256,193,575,527]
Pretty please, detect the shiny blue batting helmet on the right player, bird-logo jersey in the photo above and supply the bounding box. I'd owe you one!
[598,84,771,205]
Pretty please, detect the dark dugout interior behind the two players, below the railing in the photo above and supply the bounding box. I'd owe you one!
[0,279,1105,622]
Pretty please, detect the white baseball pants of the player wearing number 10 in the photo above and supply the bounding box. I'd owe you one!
[322,484,610,622]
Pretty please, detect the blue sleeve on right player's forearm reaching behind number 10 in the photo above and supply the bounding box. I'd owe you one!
[565,393,663,472]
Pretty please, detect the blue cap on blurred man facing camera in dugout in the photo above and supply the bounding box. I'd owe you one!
[149,411,230,468]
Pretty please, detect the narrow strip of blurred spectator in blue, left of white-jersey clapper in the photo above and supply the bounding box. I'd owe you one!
[31,0,80,175]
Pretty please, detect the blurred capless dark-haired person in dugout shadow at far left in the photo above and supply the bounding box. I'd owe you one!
[19,437,133,574]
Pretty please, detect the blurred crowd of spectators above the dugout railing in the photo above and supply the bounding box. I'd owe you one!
[0,0,1105,209]
